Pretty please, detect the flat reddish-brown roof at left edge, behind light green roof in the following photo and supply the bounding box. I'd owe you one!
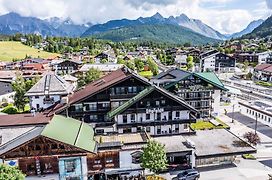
[0,113,52,127]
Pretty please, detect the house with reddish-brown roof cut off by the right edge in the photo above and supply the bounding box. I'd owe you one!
[254,64,272,82]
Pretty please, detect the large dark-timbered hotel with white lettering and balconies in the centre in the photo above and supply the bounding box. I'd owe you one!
[50,67,195,134]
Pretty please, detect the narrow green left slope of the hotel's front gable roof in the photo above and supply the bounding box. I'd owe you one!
[108,86,155,119]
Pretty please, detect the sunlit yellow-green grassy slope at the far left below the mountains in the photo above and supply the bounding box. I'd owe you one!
[0,41,58,61]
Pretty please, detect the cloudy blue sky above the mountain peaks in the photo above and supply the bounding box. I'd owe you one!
[0,0,272,33]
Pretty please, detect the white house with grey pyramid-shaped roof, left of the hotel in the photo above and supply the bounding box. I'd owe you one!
[25,72,75,110]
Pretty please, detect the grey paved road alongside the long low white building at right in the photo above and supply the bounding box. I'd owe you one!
[227,112,272,138]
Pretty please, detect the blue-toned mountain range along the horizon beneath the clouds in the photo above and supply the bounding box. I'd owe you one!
[0,12,263,42]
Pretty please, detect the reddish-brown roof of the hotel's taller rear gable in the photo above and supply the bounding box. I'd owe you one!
[51,67,150,114]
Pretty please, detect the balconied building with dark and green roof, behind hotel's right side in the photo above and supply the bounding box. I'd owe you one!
[151,68,227,118]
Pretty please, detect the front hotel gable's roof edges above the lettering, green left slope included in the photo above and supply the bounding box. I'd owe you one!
[107,85,198,119]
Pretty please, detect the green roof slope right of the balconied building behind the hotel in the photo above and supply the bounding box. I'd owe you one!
[193,72,228,91]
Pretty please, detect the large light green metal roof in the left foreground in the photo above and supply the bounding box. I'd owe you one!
[41,115,96,152]
